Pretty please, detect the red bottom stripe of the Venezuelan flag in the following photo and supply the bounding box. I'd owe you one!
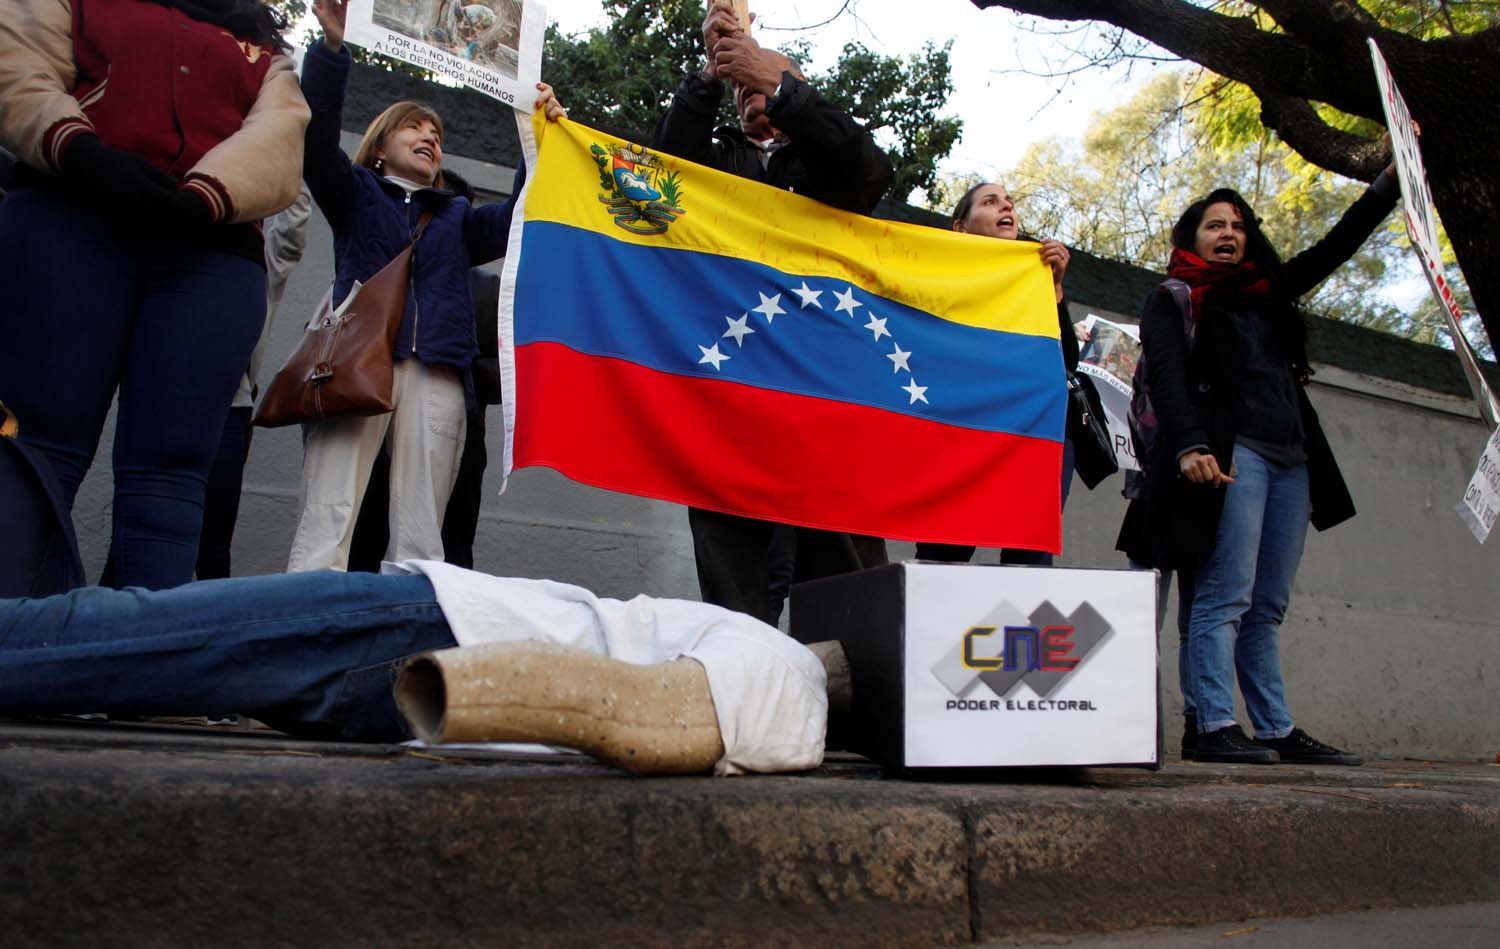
[515,343,1062,553]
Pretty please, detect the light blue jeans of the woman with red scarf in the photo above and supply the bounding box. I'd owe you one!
[1188,445,1311,738]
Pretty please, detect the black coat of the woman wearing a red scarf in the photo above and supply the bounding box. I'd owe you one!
[1116,175,1397,568]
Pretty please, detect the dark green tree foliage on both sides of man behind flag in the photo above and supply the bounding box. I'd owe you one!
[543,0,963,199]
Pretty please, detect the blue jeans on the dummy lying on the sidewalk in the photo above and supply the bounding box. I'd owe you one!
[0,573,455,741]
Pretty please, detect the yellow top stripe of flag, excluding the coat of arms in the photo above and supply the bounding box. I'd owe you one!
[525,112,1058,339]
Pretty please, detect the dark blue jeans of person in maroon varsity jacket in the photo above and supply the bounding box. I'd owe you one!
[0,187,266,589]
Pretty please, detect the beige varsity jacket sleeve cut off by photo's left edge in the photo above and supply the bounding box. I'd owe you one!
[0,0,88,173]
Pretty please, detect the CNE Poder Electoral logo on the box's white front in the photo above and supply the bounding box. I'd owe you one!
[932,600,1115,712]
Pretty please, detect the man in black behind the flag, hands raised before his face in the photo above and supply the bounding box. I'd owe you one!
[656,0,893,624]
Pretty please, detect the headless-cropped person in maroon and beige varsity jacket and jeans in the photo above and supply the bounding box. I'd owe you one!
[0,0,308,589]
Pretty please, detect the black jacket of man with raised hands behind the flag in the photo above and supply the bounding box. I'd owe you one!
[653,73,893,214]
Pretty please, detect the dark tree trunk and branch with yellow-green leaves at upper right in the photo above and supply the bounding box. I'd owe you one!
[974,0,1500,355]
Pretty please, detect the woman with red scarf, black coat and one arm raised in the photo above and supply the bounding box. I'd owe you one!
[1121,169,1397,765]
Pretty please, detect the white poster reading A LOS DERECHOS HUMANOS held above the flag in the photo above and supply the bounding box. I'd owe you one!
[344,0,548,114]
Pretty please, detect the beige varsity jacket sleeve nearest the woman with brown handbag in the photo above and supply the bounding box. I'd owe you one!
[183,55,312,222]
